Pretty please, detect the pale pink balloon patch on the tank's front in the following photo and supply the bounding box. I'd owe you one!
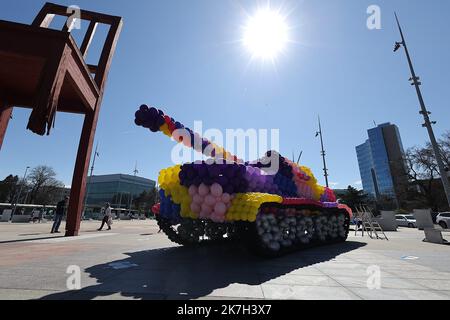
[189,183,234,223]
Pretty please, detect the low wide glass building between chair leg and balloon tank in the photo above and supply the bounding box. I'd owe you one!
[86,174,156,208]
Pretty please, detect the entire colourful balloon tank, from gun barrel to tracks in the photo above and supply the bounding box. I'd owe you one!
[135,105,352,256]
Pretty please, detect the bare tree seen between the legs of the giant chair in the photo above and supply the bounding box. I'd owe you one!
[28,166,64,204]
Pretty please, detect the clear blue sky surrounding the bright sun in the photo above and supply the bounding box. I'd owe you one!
[0,0,450,188]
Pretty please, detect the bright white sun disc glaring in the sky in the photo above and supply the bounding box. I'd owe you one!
[242,8,289,60]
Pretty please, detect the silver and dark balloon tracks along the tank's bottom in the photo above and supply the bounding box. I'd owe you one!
[157,204,350,257]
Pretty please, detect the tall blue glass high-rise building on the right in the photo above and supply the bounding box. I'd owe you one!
[356,123,408,200]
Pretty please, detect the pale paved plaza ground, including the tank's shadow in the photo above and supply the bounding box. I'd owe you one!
[0,220,450,300]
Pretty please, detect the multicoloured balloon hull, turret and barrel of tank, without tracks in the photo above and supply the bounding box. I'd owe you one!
[135,105,336,222]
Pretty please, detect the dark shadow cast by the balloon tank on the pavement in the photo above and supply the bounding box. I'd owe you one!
[42,241,366,300]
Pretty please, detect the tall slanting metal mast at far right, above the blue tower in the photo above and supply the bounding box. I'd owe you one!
[394,13,450,206]
